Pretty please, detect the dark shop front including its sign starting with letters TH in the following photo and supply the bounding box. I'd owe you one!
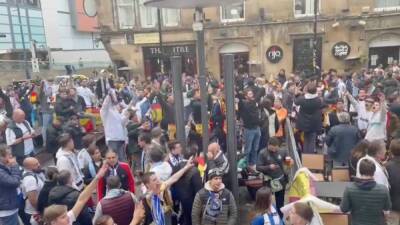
[142,44,197,76]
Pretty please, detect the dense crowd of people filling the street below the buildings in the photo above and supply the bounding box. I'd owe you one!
[0,59,400,225]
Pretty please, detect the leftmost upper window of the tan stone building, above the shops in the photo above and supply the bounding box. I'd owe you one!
[116,0,135,29]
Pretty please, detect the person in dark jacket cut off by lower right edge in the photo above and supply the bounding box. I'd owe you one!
[386,139,400,225]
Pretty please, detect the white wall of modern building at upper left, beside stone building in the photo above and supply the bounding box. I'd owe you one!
[41,0,111,67]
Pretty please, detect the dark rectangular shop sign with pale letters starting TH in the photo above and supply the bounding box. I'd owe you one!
[143,45,196,58]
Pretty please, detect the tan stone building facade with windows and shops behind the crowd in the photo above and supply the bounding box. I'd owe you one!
[97,0,400,77]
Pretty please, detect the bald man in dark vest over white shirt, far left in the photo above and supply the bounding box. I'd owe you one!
[6,109,36,165]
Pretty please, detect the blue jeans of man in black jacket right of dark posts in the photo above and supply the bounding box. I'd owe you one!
[244,127,261,166]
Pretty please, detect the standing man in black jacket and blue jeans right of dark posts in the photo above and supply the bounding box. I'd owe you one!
[239,89,261,170]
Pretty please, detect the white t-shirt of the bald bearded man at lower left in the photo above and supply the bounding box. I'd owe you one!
[21,171,45,215]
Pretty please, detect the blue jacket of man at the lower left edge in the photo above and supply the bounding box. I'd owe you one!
[0,163,22,211]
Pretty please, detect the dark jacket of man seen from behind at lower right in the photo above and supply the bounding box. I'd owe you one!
[340,178,391,225]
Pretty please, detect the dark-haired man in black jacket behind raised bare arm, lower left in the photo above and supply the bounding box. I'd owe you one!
[49,170,92,225]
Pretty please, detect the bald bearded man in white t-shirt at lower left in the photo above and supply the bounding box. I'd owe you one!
[21,157,45,225]
